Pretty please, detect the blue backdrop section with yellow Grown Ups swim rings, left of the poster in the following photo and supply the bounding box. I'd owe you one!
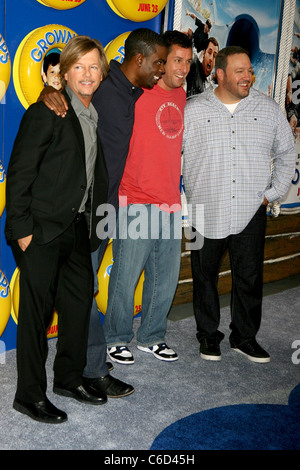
[0,0,167,353]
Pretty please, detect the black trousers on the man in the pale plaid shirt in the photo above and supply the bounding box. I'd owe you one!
[191,206,266,344]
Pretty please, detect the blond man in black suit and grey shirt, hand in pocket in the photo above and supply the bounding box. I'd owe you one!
[5,36,108,423]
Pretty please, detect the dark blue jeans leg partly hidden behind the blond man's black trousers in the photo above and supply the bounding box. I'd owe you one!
[83,240,108,378]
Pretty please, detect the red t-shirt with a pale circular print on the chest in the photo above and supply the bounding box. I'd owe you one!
[119,85,186,212]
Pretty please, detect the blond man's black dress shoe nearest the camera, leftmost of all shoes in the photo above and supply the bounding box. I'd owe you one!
[13,398,68,424]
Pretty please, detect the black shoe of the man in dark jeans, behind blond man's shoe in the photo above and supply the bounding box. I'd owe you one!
[83,374,134,398]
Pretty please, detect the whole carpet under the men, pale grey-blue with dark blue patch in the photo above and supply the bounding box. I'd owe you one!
[0,287,300,450]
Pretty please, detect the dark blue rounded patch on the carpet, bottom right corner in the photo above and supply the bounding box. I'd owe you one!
[151,384,300,450]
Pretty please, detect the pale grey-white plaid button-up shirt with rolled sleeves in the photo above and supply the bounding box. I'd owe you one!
[183,88,296,238]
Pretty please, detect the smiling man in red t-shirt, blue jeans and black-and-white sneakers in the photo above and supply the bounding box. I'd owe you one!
[103,31,192,364]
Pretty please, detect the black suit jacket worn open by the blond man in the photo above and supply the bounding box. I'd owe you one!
[5,92,107,248]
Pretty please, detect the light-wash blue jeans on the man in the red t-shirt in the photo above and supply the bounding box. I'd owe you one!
[103,204,181,347]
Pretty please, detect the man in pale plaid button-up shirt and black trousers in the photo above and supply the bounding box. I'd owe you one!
[183,46,296,363]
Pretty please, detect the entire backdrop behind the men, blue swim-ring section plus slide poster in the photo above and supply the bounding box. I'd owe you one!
[0,0,300,354]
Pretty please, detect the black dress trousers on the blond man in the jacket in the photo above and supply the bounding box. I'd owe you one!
[12,216,93,403]
